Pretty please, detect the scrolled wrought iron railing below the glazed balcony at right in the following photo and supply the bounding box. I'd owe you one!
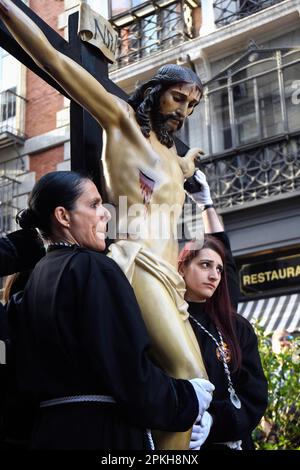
[203,134,300,209]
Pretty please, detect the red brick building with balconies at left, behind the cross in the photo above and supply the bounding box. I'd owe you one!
[0,0,69,234]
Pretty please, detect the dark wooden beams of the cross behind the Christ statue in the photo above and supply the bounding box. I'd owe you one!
[0,0,188,198]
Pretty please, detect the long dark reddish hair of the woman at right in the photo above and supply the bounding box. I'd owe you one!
[178,235,241,370]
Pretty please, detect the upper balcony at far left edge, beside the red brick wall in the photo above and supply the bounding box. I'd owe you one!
[0,88,26,148]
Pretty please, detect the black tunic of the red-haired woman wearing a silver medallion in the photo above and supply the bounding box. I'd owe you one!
[189,232,268,450]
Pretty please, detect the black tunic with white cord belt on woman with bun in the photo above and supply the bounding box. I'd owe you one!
[9,244,198,449]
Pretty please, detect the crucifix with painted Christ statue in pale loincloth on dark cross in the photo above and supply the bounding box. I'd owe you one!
[0,0,206,449]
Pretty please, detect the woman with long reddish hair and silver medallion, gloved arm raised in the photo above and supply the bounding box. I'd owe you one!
[178,170,268,450]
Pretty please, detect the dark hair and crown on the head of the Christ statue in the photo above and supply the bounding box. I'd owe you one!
[128,64,203,148]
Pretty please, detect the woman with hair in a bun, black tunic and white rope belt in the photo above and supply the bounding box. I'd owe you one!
[8,171,214,449]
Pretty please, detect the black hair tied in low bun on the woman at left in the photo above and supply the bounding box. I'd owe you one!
[16,171,89,239]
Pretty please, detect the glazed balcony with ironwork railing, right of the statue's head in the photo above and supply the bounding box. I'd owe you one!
[194,48,300,208]
